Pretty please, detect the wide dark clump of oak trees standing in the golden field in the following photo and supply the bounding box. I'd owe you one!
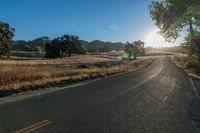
[45,34,87,58]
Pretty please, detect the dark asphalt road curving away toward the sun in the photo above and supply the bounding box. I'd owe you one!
[0,57,199,133]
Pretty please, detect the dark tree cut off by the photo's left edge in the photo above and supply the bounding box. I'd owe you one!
[0,22,15,57]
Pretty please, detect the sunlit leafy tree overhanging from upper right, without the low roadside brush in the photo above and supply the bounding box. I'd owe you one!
[149,0,200,61]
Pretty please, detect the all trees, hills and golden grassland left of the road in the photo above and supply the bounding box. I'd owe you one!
[0,22,156,97]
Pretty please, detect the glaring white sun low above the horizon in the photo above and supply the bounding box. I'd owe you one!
[145,30,172,47]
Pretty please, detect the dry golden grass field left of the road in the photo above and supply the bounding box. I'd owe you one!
[0,55,156,96]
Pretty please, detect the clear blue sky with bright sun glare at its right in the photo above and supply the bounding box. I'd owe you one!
[0,0,183,47]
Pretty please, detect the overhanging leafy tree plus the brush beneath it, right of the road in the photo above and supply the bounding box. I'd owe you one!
[149,0,200,75]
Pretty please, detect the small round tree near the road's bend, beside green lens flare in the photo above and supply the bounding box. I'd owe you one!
[125,40,145,60]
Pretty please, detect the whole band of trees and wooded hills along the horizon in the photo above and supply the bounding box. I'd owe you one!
[0,22,181,59]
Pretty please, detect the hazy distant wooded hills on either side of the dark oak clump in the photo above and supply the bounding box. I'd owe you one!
[12,37,125,53]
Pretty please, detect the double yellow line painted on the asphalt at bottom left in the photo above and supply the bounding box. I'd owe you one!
[14,120,52,133]
